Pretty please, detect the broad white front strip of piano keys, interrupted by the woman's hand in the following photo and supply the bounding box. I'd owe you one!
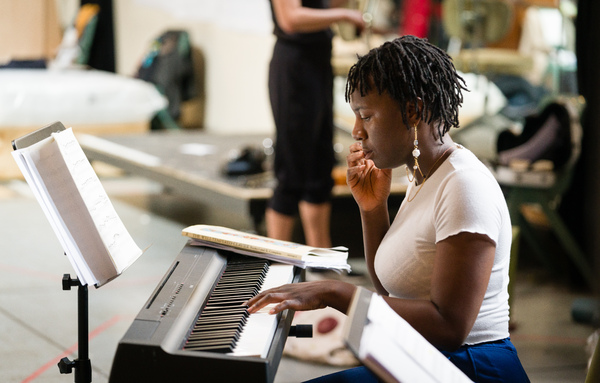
[229,263,294,358]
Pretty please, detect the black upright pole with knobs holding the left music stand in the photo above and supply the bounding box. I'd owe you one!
[58,274,92,383]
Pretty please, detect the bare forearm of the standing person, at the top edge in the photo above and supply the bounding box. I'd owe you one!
[273,0,365,33]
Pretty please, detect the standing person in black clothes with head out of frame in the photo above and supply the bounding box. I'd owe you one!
[265,0,364,247]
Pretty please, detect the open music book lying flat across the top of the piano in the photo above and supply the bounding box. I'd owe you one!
[182,225,350,271]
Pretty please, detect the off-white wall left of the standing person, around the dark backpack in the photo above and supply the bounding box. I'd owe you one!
[113,0,274,134]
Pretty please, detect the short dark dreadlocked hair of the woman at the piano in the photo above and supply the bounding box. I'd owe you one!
[345,35,468,139]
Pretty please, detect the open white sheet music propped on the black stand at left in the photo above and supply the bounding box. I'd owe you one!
[12,123,142,287]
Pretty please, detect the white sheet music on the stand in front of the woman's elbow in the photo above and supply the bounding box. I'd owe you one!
[344,287,472,383]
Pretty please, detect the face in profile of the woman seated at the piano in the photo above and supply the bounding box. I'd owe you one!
[350,89,414,169]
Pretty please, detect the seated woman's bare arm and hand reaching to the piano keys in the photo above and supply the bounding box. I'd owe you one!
[246,232,495,351]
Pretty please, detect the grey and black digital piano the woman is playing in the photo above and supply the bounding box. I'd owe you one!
[109,244,300,383]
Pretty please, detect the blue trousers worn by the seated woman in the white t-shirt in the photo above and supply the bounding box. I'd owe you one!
[307,338,529,383]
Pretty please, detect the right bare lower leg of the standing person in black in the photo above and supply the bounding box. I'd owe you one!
[298,201,331,247]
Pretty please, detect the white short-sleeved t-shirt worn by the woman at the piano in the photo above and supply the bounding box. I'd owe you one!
[375,147,512,344]
